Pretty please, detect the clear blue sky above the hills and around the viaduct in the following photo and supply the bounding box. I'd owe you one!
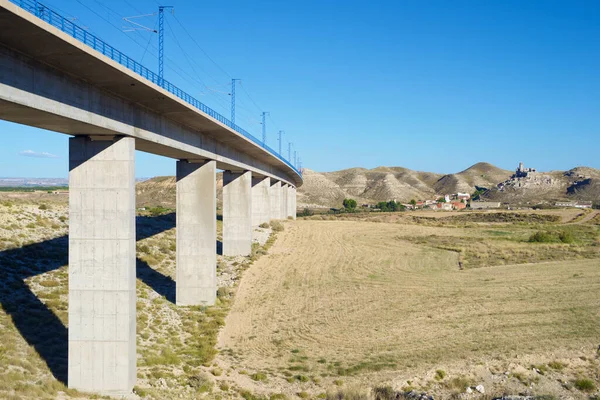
[0,0,600,177]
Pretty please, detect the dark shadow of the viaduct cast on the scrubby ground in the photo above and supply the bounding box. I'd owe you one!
[0,213,175,384]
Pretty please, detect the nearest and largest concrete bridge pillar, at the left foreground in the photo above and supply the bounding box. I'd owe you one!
[68,136,136,395]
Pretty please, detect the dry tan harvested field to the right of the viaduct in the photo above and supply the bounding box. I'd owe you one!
[217,219,600,399]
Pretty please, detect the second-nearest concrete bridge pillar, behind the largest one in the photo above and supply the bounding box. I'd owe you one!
[175,161,217,306]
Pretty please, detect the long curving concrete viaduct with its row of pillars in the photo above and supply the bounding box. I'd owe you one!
[0,0,302,394]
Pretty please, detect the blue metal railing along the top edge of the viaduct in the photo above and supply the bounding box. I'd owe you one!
[10,0,302,176]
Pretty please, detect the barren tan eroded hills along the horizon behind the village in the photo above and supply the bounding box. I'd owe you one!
[137,162,600,208]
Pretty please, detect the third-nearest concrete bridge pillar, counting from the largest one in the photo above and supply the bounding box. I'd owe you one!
[223,171,252,256]
